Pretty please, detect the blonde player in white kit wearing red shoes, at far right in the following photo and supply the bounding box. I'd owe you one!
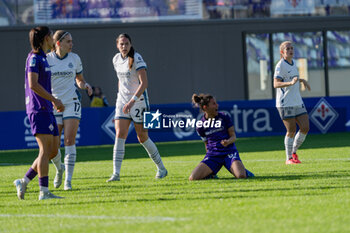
[273,41,310,164]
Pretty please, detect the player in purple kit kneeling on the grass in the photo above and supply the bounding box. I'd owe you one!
[189,94,254,180]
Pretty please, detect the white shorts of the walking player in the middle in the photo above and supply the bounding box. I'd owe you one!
[114,98,150,124]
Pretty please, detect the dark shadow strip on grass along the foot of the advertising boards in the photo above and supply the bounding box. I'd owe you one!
[0,132,350,166]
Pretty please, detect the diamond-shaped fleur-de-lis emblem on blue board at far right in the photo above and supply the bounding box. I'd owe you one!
[310,98,339,134]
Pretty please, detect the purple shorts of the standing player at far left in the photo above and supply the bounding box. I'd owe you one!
[28,112,58,136]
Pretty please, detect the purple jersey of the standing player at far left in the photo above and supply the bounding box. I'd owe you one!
[24,50,52,114]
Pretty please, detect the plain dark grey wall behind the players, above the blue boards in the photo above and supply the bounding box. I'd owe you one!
[0,17,350,111]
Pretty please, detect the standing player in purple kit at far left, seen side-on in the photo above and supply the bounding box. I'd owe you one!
[14,26,64,200]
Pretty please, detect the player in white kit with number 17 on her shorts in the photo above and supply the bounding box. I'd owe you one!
[47,30,92,190]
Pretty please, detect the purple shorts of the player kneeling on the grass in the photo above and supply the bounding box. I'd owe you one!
[201,151,242,175]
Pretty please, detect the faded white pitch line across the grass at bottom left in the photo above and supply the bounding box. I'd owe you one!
[0,214,189,222]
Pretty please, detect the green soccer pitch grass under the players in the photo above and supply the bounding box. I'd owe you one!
[0,133,350,233]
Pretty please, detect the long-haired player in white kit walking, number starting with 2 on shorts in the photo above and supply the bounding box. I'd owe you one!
[107,34,168,182]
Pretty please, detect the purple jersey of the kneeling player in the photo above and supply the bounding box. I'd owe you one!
[197,112,237,156]
